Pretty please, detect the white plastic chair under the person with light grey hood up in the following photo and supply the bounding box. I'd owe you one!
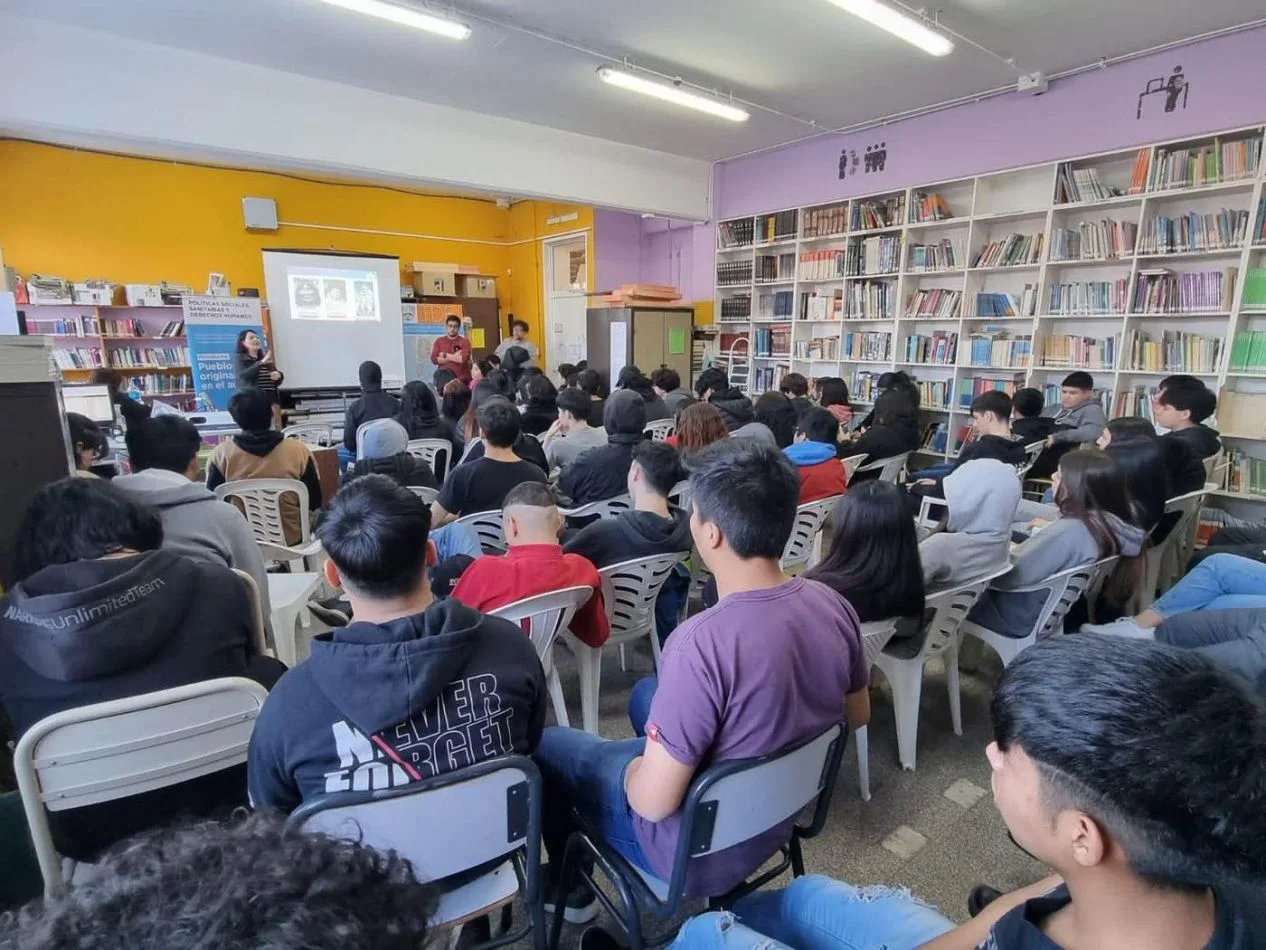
[875,564,1012,771]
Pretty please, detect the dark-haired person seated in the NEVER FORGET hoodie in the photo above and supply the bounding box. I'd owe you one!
[247,476,547,812]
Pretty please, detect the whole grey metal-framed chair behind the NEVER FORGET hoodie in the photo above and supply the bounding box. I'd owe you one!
[286,755,546,950]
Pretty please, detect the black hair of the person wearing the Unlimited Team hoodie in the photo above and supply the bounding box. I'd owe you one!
[13,478,162,580]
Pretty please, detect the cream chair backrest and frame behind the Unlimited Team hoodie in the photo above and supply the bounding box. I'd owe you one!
[13,676,268,896]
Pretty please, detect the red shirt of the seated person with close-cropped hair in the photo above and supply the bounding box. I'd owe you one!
[453,547,610,647]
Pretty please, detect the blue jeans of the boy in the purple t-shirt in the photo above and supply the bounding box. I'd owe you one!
[532,726,653,871]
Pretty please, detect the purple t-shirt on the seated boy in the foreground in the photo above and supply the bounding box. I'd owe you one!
[633,578,870,896]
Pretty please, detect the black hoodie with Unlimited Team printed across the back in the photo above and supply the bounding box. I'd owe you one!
[0,550,272,860]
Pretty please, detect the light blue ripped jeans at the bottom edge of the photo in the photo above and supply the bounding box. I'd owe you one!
[672,874,953,950]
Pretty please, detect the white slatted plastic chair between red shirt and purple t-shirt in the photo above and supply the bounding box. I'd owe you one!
[566,554,687,736]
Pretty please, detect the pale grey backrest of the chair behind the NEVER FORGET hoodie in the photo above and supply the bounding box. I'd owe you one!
[286,742,541,880]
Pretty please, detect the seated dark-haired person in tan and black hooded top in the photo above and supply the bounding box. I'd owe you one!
[206,389,322,545]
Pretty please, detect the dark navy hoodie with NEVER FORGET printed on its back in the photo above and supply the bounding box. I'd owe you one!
[248,599,546,812]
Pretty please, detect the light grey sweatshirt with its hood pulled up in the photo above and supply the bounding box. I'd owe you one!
[919,459,1020,588]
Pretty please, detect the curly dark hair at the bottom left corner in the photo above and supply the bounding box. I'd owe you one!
[0,811,438,950]
